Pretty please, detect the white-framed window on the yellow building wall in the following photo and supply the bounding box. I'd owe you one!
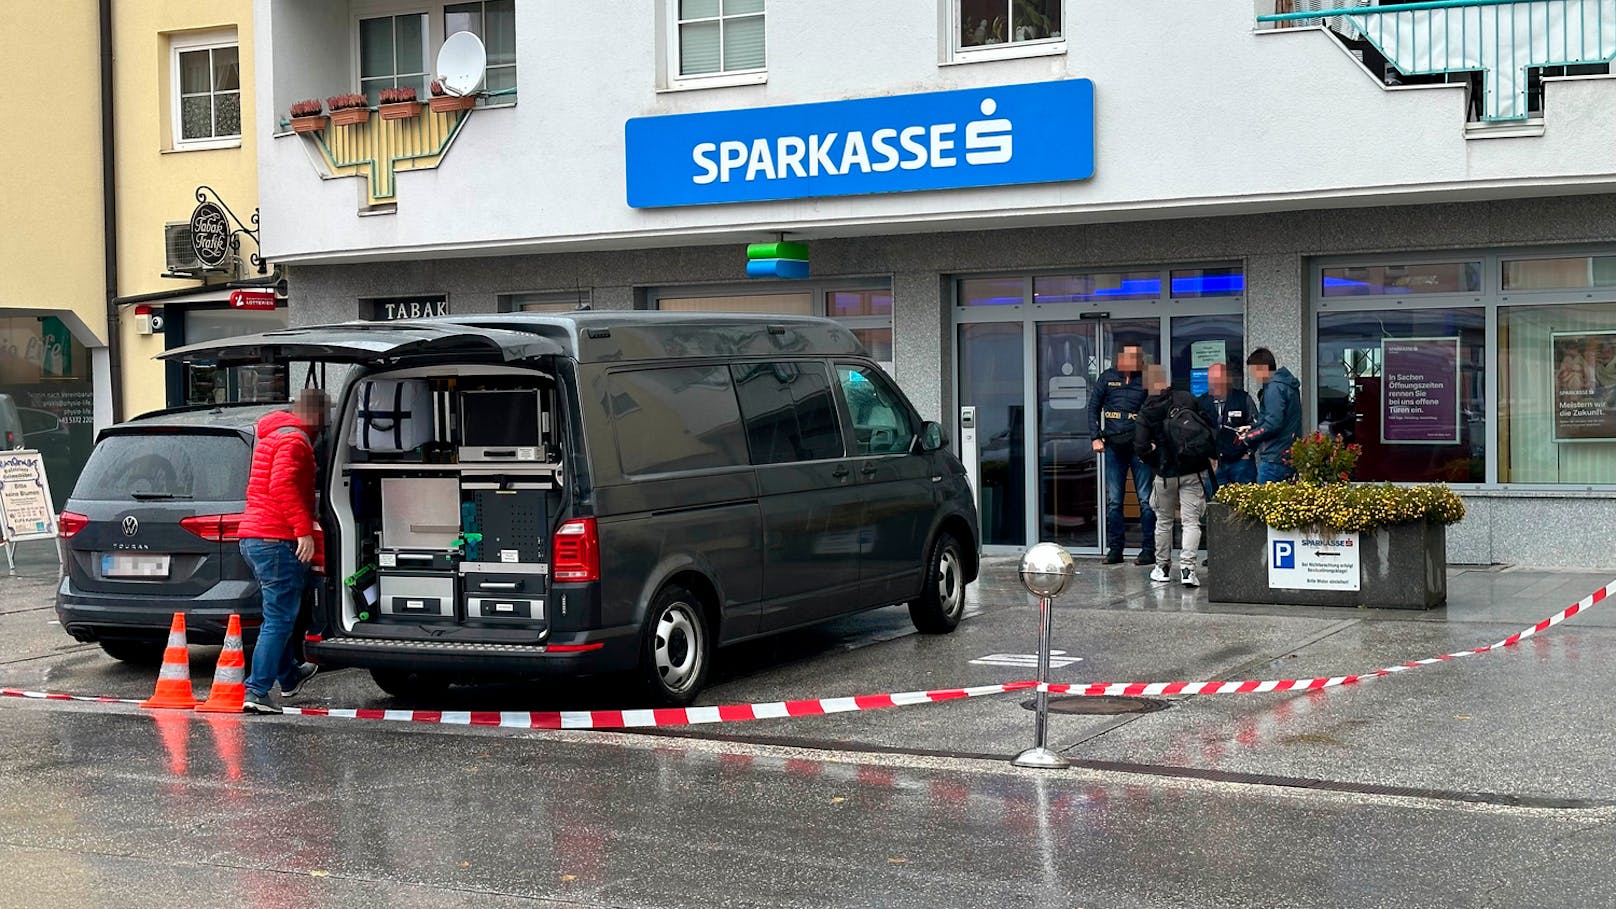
[170,31,241,149]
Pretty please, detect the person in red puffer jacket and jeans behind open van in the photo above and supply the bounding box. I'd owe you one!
[241,388,326,713]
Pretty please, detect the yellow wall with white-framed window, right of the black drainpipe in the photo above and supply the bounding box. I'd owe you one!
[115,0,259,416]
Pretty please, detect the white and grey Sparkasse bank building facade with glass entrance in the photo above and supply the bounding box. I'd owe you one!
[255,0,1616,566]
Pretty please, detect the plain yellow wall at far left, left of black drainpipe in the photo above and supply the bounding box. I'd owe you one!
[0,0,107,346]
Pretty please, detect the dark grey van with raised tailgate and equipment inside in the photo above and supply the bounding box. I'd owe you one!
[165,312,979,705]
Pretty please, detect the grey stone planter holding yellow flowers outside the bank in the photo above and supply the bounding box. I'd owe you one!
[1206,501,1448,610]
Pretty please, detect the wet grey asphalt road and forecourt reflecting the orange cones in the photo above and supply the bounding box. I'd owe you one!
[0,549,1616,907]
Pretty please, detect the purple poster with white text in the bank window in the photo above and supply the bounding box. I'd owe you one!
[1380,336,1459,445]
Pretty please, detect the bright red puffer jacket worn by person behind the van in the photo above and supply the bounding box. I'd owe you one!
[239,411,315,540]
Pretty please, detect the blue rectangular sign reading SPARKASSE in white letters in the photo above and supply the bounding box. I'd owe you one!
[624,79,1094,209]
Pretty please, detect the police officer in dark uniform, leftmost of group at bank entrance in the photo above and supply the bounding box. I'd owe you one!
[1089,345,1155,564]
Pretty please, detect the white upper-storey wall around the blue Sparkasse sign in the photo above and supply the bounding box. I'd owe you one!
[257,0,1616,262]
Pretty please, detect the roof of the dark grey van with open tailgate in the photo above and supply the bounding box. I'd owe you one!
[422,311,865,362]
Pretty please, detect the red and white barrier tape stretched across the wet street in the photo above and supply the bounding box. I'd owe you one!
[0,581,1616,729]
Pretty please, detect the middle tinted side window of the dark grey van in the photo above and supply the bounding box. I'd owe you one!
[729,361,844,464]
